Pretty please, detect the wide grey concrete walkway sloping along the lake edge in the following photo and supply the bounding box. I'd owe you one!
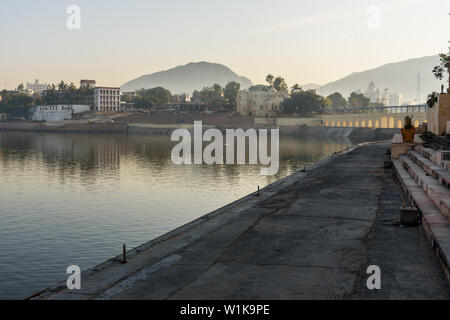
[36,143,450,299]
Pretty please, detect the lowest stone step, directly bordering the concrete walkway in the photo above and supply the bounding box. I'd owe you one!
[392,159,450,281]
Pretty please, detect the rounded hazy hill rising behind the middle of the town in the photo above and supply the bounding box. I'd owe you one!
[121,62,252,94]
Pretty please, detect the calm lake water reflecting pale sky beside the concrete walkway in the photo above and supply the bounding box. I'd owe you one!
[0,132,350,299]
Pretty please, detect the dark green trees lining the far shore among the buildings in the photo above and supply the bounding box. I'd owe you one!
[0,74,390,117]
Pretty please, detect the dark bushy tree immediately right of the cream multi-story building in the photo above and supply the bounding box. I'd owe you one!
[283,90,327,116]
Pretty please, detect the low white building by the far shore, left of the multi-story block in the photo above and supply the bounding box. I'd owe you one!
[32,105,91,121]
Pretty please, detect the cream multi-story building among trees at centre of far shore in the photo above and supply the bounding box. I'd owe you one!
[236,87,289,118]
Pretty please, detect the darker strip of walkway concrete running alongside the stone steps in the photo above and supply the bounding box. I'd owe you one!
[352,171,450,299]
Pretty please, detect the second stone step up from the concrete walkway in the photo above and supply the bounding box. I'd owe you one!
[399,155,450,219]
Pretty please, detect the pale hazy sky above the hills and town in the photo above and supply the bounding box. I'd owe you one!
[0,0,450,89]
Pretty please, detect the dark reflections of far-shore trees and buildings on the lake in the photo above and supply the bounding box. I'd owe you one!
[0,132,351,182]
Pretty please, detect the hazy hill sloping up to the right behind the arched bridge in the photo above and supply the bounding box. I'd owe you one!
[317,55,444,102]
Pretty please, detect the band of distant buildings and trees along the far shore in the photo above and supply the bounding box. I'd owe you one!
[0,74,428,126]
